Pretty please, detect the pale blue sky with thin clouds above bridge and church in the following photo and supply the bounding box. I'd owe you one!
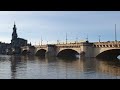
[0,11,120,45]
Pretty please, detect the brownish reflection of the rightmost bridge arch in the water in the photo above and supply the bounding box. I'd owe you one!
[97,59,120,76]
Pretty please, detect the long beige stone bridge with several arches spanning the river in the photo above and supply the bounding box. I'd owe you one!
[21,41,120,58]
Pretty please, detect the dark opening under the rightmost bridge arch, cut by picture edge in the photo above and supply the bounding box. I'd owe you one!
[96,49,120,59]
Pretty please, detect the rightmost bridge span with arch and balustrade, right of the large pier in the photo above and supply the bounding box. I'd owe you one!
[93,41,120,58]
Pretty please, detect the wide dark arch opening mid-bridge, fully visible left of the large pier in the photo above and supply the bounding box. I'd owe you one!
[57,49,79,57]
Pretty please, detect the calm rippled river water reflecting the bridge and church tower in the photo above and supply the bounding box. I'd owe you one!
[0,55,120,79]
